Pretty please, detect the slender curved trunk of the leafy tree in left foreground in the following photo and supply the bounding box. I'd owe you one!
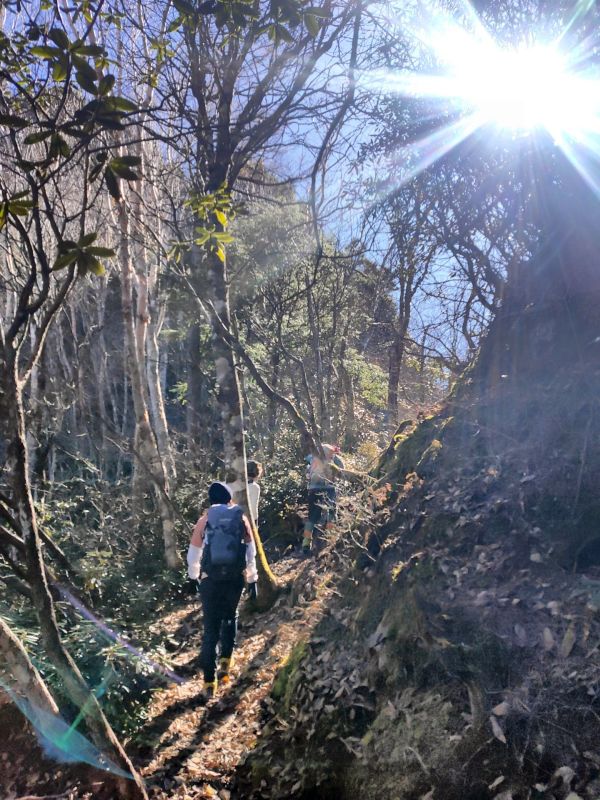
[5,352,147,800]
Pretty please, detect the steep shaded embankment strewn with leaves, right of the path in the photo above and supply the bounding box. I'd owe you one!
[238,222,600,800]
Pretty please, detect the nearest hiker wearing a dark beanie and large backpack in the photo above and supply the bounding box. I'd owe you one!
[187,482,258,702]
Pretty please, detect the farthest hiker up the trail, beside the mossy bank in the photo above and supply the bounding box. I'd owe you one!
[302,444,344,555]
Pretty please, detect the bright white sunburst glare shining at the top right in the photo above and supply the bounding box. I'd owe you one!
[358,0,600,193]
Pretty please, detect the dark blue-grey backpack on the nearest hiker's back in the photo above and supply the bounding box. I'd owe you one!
[202,505,246,581]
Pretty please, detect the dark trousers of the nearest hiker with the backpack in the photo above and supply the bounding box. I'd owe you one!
[200,578,244,683]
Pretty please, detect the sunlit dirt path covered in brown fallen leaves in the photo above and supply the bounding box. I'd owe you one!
[136,558,329,800]
